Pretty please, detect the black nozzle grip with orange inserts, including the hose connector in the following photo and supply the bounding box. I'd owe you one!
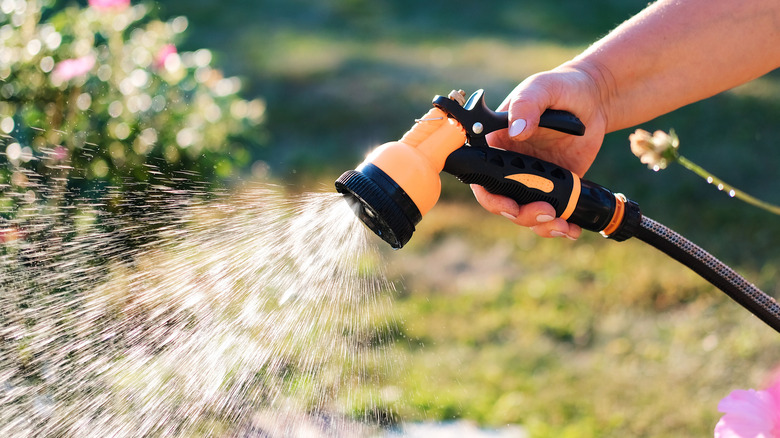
[444,146,639,240]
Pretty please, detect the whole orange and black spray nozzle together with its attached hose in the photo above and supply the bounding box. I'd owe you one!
[336,90,780,332]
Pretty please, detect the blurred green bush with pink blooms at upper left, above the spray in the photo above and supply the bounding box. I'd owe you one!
[0,0,264,204]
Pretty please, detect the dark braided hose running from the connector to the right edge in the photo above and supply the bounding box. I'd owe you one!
[635,216,780,332]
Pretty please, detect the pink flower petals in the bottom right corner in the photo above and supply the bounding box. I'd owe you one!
[715,380,780,438]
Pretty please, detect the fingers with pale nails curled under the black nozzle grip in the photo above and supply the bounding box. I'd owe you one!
[471,184,582,240]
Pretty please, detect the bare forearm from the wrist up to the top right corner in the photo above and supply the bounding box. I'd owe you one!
[564,0,780,132]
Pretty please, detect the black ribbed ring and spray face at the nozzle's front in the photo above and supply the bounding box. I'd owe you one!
[336,163,422,249]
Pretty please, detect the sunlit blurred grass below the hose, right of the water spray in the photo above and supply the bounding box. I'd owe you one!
[374,205,778,437]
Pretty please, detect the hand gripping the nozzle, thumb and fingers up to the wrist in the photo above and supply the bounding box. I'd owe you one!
[471,65,607,239]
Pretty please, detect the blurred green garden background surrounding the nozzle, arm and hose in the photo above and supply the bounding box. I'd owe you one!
[4,0,780,437]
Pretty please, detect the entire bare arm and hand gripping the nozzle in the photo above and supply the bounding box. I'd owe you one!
[472,0,780,239]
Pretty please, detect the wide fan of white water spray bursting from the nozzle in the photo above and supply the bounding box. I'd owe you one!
[0,130,398,438]
